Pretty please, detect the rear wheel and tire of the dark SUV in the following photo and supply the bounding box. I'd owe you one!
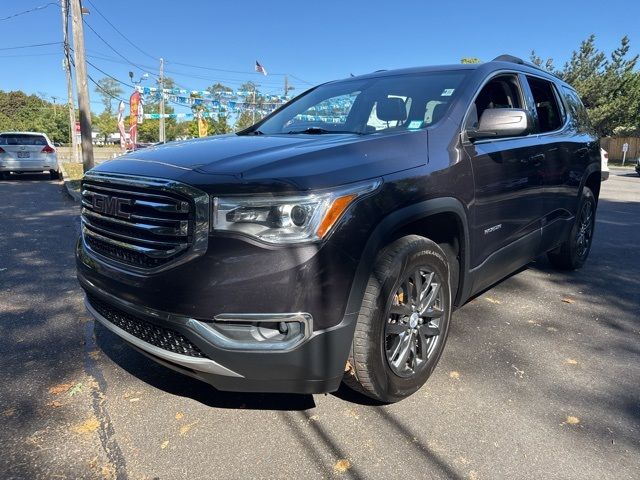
[547,187,596,270]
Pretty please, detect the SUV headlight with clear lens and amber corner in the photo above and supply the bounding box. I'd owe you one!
[211,180,382,244]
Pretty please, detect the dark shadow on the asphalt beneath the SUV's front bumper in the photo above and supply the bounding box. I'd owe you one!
[94,322,316,411]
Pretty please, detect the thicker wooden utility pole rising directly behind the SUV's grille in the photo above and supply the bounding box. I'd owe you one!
[71,0,93,172]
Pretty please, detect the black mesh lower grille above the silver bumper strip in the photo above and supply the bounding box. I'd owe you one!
[87,295,208,358]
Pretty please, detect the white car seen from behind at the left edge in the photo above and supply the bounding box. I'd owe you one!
[0,132,60,179]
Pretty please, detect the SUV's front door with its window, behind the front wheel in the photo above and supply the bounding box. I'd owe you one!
[463,73,543,280]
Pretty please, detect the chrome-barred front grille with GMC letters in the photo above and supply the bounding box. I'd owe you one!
[82,174,208,272]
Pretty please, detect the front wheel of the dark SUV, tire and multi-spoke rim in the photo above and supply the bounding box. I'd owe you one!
[345,235,451,403]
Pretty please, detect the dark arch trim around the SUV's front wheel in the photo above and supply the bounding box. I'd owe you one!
[345,197,471,315]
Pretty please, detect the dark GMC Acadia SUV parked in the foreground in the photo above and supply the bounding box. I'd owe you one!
[77,56,600,402]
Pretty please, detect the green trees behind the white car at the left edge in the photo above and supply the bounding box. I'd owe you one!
[0,90,69,143]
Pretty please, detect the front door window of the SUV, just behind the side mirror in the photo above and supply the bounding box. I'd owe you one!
[466,75,524,128]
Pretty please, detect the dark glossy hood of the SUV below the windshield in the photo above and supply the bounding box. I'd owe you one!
[92,131,427,189]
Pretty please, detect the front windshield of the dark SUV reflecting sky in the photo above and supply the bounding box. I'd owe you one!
[243,70,467,135]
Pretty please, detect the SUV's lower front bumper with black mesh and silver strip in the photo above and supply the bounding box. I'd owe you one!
[80,278,355,393]
